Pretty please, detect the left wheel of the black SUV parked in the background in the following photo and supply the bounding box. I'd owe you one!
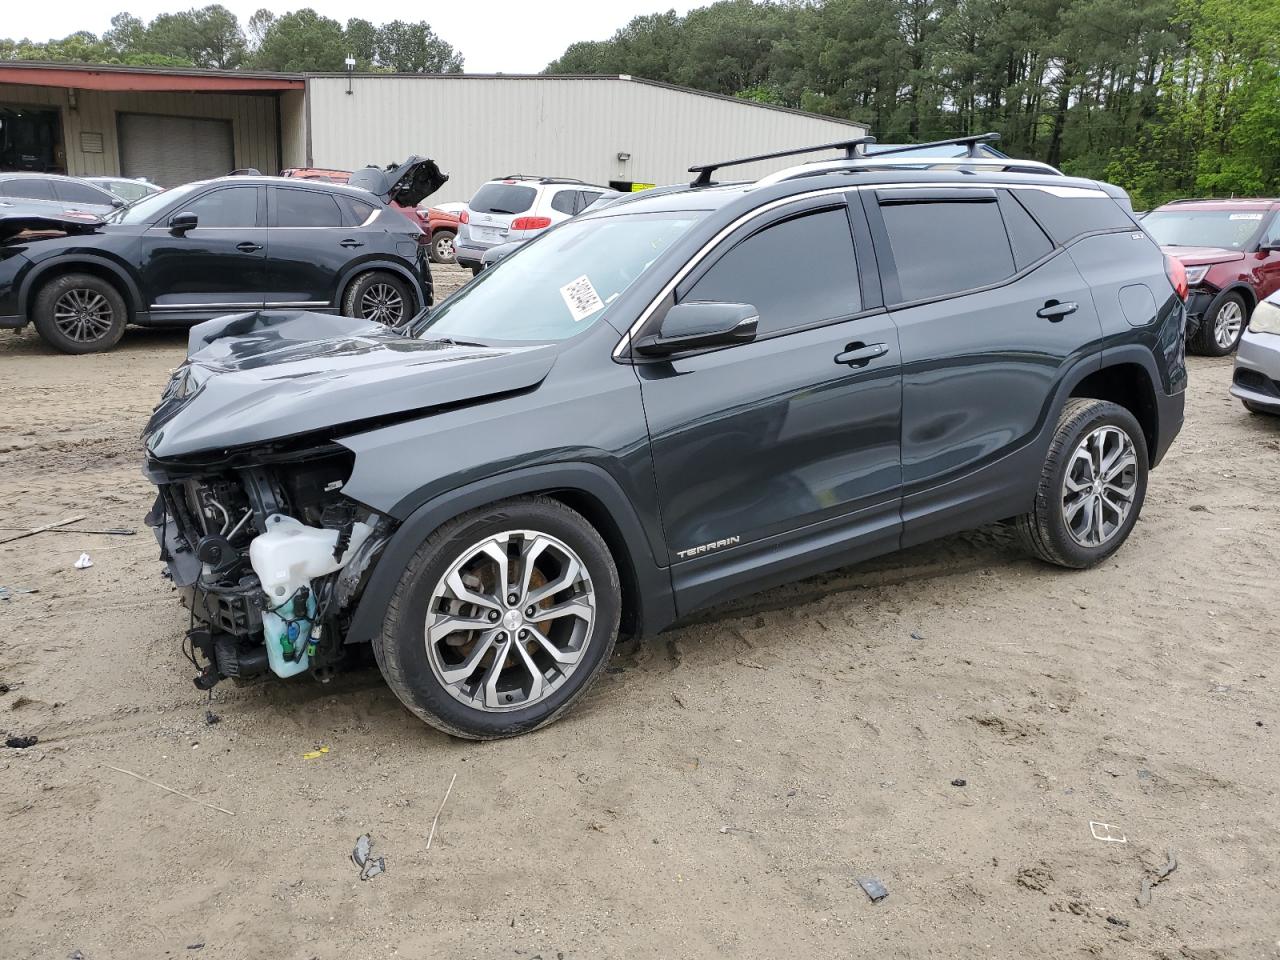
[32,274,129,353]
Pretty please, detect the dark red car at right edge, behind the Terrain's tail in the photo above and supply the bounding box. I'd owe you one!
[1142,198,1280,357]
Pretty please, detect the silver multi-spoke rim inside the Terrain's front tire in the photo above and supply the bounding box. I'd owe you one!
[424,530,596,712]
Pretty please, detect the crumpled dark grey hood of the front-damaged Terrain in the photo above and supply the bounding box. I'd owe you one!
[143,311,556,460]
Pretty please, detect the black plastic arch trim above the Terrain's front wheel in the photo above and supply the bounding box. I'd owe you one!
[346,463,676,643]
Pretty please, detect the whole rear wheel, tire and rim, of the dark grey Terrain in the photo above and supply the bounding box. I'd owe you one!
[1016,397,1148,570]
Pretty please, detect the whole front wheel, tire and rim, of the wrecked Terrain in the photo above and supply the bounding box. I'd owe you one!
[374,497,622,740]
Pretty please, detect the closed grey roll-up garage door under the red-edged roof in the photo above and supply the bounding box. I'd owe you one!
[118,114,236,187]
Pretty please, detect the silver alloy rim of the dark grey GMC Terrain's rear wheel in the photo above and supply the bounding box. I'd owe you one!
[1062,425,1138,547]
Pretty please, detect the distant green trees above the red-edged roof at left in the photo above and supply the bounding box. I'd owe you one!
[0,4,462,73]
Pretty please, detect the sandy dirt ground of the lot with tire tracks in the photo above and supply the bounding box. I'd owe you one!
[0,271,1280,960]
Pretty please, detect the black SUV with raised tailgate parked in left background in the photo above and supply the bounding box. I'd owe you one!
[0,157,448,353]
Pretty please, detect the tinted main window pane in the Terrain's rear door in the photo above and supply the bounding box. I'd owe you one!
[881,201,1014,302]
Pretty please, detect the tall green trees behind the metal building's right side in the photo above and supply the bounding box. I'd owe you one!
[547,0,1280,206]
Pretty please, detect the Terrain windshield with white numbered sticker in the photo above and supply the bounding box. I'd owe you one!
[421,210,705,342]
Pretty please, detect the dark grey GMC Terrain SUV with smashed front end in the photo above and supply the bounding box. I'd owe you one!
[146,135,1187,739]
